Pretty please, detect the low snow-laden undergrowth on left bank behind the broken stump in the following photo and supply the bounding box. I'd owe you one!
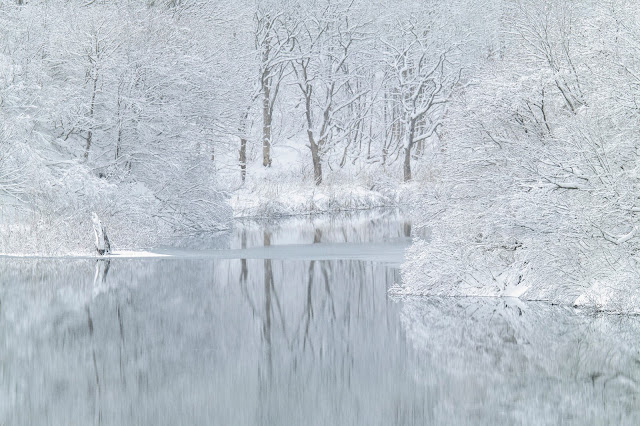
[0,142,231,255]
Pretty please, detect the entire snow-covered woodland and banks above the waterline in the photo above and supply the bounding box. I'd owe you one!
[0,0,640,312]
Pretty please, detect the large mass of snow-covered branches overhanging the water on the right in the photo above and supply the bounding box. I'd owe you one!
[405,0,639,310]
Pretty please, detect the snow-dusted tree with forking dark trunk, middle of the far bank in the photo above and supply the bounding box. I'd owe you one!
[292,4,367,185]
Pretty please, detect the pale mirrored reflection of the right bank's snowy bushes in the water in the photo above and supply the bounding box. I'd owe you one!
[401,298,640,424]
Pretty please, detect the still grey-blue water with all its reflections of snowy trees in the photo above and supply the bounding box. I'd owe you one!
[0,211,640,425]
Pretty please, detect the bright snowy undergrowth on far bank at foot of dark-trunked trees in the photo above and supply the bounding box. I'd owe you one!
[229,141,423,217]
